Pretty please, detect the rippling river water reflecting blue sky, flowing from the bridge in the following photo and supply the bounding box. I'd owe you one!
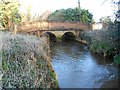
[51,41,118,88]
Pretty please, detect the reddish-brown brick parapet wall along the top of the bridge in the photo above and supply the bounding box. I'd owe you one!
[17,21,90,32]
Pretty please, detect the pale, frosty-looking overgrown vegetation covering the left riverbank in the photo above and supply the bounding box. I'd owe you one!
[0,32,58,88]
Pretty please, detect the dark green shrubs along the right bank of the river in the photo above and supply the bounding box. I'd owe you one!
[80,22,120,64]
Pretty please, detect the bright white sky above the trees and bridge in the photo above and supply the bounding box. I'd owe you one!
[20,0,114,21]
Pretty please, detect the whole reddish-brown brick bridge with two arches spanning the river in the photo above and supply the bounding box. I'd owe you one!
[16,21,90,41]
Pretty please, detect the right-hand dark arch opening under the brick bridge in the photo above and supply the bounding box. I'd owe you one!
[61,32,76,41]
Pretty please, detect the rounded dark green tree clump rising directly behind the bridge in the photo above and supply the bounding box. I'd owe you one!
[48,8,93,23]
